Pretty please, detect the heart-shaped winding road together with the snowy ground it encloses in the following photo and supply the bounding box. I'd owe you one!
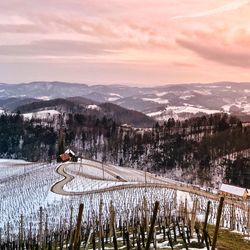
[51,160,248,208]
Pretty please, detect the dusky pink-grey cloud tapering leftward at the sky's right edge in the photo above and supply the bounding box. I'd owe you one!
[176,29,250,68]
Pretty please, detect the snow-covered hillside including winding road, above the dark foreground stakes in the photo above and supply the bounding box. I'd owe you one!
[0,157,247,249]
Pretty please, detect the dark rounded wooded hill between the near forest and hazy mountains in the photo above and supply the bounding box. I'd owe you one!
[15,97,155,128]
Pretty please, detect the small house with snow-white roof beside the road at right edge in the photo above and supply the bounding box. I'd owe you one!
[219,183,250,200]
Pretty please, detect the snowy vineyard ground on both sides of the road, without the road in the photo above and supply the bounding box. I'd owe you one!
[0,160,247,242]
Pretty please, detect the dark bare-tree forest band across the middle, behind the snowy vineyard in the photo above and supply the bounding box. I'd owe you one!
[0,114,250,187]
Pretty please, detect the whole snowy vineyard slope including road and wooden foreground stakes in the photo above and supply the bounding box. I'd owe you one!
[0,160,250,249]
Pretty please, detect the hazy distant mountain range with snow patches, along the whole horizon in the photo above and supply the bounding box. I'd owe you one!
[0,82,250,120]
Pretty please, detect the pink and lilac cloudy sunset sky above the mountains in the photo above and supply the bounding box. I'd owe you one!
[0,0,250,86]
